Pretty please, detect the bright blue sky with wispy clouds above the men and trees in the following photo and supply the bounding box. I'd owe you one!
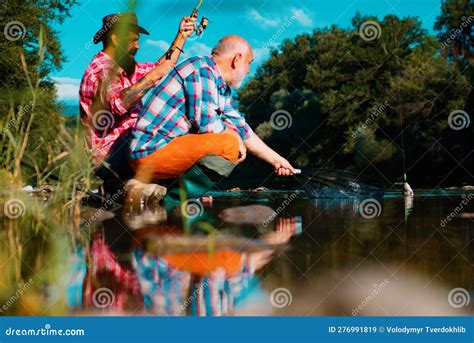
[52,0,441,105]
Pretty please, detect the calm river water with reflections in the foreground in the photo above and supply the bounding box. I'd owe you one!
[0,189,474,316]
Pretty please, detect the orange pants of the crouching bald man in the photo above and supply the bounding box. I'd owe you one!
[131,133,239,183]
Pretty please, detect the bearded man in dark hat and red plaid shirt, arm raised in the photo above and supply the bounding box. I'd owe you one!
[79,13,196,192]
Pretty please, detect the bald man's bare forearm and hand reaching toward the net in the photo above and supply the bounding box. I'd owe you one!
[244,131,295,176]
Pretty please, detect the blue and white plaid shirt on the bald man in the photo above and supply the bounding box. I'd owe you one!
[131,56,251,159]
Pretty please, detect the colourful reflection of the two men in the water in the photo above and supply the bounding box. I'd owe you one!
[70,218,296,316]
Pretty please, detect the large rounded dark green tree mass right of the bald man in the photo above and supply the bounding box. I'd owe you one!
[239,14,469,187]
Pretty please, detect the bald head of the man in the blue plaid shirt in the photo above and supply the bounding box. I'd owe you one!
[212,35,253,88]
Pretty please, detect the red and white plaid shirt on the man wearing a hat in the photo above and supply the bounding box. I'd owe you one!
[79,51,159,162]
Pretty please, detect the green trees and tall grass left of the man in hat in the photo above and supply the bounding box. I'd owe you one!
[0,0,76,184]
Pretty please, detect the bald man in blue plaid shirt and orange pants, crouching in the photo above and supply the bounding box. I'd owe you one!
[131,36,295,189]
